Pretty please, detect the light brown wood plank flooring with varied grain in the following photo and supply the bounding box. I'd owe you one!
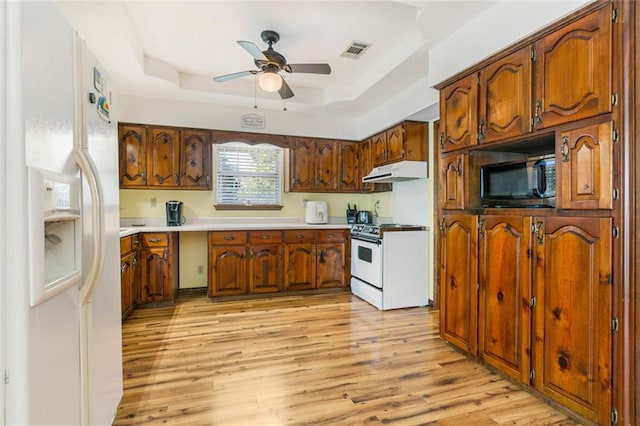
[114,292,577,425]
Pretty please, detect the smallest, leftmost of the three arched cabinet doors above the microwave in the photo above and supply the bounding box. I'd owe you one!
[440,74,478,152]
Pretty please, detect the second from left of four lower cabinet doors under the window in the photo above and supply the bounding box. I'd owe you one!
[249,244,282,293]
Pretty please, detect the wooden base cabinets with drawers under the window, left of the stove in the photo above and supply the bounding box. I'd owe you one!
[208,229,349,297]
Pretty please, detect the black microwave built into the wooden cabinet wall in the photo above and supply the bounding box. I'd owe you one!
[480,154,556,207]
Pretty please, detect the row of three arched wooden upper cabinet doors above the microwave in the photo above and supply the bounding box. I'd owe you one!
[439,2,612,152]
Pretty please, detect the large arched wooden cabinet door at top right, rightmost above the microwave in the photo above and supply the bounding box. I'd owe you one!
[535,5,612,128]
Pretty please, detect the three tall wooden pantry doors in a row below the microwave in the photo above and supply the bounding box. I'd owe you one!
[439,215,613,424]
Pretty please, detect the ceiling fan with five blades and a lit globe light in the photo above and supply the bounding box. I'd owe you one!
[213,30,331,99]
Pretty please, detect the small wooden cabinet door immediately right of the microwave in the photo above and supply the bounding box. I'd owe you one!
[556,122,614,209]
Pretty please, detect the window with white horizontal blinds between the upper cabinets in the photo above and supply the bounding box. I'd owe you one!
[216,142,282,209]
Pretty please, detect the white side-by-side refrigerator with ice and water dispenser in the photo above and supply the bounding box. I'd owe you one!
[0,1,122,425]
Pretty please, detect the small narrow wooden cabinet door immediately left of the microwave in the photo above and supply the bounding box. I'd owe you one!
[440,154,469,210]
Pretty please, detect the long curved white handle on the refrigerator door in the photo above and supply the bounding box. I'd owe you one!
[75,147,104,305]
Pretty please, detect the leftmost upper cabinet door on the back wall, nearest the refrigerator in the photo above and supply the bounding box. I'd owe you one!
[118,125,147,188]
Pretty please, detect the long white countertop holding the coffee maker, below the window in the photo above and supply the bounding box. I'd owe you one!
[120,218,351,237]
